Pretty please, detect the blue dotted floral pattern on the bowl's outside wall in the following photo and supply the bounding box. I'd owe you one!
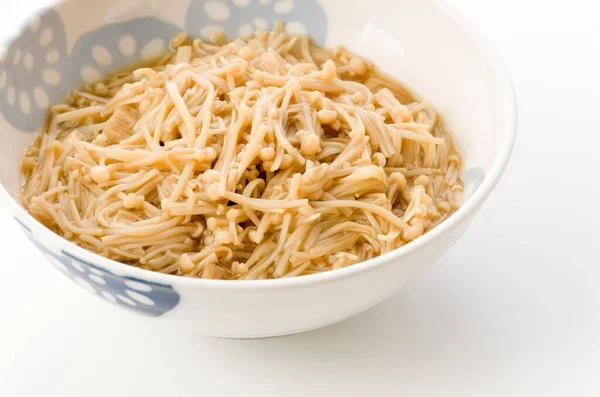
[17,219,180,317]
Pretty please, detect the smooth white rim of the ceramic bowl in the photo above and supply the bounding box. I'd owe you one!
[0,0,517,292]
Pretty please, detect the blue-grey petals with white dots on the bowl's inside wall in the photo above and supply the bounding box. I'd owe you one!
[0,0,328,132]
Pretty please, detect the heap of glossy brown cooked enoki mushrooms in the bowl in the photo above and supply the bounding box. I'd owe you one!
[16,24,462,280]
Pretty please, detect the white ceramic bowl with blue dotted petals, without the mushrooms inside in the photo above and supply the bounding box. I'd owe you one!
[0,0,516,338]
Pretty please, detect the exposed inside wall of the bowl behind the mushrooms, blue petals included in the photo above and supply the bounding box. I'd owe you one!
[0,0,511,209]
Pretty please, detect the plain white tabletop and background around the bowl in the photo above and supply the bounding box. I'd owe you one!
[0,0,600,397]
